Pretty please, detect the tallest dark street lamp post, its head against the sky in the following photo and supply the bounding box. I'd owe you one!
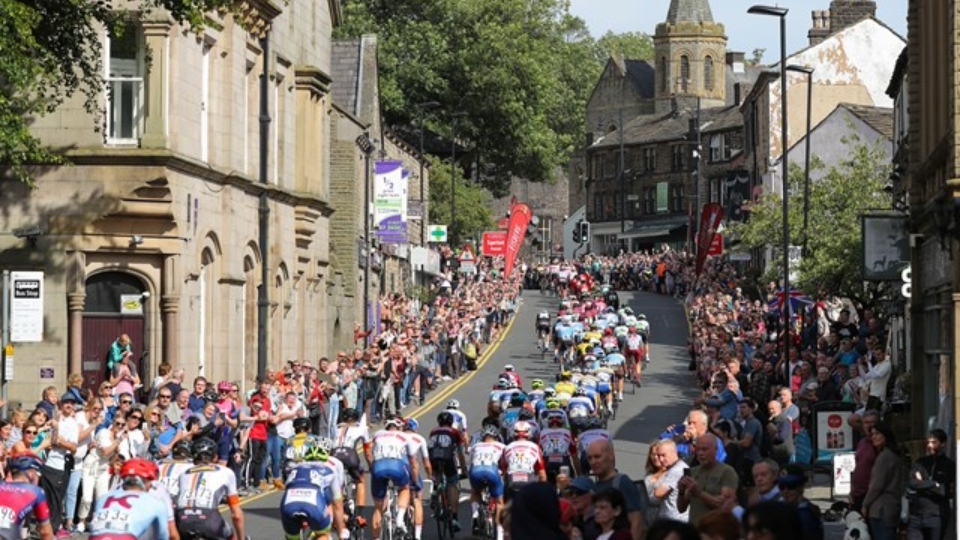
[747,5,790,362]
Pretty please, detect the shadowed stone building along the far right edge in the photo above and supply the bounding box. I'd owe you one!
[900,0,960,446]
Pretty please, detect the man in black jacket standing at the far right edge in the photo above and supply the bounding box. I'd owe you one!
[907,429,956,540]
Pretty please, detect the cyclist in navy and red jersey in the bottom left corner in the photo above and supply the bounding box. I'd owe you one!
[0,454,53,540]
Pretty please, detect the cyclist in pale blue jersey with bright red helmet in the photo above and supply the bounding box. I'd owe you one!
[90,459,170,540]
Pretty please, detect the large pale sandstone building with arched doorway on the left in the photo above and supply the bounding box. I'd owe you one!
[0,0,341,403]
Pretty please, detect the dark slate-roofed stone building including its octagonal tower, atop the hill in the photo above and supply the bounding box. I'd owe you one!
[570,0,760,252]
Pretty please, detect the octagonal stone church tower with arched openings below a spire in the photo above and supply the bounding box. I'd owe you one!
[653,0,727,114]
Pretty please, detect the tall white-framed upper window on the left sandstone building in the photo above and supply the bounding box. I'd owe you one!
[103,24,144,144]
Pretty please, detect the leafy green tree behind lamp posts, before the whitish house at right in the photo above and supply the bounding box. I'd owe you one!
[729,139,892,307]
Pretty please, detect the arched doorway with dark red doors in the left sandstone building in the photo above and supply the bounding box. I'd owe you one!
[83,272,150,389]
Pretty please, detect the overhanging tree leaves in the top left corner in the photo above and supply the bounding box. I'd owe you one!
[0,0,234,183]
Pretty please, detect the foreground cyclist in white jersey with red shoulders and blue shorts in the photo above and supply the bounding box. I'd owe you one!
[370,415,420,538]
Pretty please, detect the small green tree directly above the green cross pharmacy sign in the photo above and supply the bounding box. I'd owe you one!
[429,157,493,246]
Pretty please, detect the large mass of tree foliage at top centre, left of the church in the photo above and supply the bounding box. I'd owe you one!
[336,0,636,194]
